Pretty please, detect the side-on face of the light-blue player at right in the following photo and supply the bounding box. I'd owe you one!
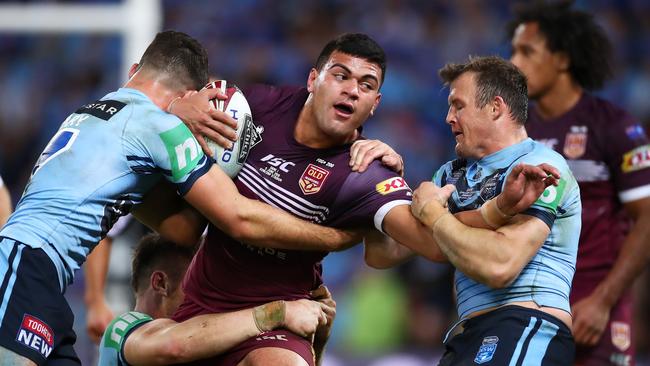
[446,72,494,159]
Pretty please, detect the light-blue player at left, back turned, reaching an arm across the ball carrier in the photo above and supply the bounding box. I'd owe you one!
[0,31,355,365]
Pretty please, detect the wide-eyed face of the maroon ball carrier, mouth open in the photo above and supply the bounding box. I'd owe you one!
[307,51,382,140]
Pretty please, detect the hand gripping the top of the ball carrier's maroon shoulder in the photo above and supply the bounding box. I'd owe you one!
[350,140,404,177]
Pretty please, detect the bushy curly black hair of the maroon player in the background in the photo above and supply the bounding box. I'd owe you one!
[507,1,612,90]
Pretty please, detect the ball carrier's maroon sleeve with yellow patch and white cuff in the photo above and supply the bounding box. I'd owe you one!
[331,161,413,230]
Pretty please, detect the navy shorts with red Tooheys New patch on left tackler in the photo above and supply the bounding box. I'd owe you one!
[0,238,81,365]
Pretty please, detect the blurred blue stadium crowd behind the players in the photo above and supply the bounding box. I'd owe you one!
[0,0,650,365]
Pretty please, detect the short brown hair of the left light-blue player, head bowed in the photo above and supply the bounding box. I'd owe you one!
[138,30,208,90]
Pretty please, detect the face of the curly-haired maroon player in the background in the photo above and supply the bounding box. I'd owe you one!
[510,22,562,99]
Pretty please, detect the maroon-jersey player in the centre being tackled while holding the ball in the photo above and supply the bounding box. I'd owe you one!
[140,34,557,365]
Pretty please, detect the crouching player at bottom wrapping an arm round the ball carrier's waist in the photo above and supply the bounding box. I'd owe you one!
[99,234,336,366]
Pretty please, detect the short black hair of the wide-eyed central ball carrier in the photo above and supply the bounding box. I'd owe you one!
[315,33,386,84]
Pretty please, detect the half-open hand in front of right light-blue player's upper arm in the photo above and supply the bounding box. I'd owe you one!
[497,163,560,215]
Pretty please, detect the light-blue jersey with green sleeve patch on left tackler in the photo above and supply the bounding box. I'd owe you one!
[0,88,212,290]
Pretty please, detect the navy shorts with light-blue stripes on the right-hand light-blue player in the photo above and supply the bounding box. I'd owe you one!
[439,306,575,366]
